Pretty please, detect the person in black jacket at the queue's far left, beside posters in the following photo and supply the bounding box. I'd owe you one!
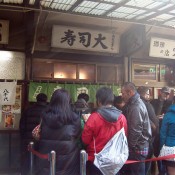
[19,93,47,175]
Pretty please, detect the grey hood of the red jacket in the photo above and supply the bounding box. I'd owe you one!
[97,106,122,122]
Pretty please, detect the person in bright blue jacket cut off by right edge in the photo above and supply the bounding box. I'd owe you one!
[160,97,175,175]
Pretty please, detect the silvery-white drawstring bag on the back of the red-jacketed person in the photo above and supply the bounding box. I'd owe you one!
[94,128,129,175]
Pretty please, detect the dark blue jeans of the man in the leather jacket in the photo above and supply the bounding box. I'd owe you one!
[125,152,147,175]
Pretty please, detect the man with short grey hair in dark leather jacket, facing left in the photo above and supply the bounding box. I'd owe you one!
[121,82,151,175]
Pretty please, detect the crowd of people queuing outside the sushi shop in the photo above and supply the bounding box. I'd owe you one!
[20,82,175,175]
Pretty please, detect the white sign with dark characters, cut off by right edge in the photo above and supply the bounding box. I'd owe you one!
[149,37,175,59]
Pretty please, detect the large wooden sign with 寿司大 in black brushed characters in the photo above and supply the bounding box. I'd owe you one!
[51,25,120,53]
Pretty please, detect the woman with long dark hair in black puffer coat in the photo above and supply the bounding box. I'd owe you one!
[38,89,81,175]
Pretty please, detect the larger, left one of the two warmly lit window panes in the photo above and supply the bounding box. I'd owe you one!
[54,63,76,79]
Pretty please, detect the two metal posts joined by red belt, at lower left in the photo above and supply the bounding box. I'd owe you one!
[28,142,56,175]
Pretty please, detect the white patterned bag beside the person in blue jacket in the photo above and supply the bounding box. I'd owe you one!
[159,145,175,161]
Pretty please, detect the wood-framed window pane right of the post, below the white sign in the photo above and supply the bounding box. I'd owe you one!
[133,63,157,81]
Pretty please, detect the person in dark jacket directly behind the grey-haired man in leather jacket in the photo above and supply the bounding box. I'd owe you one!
[137,86,159,174]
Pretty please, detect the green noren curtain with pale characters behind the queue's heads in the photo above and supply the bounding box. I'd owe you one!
[28,82,121,103]
